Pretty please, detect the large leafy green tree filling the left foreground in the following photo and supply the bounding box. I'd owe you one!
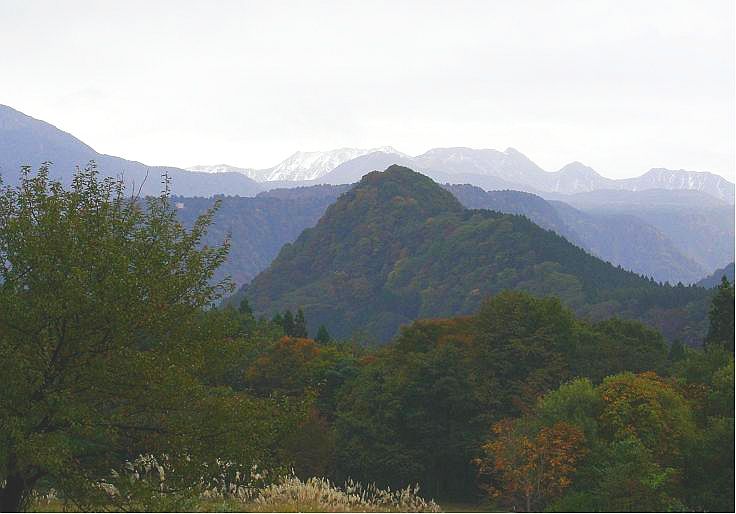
[0,165,294,511]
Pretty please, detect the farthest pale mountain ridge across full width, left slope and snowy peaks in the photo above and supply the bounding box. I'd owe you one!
[0,105,735,200]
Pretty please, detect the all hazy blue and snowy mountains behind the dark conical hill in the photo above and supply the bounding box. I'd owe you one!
[0,101,734,284]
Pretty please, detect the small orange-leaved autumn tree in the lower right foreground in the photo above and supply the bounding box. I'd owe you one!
[476,419,587,512]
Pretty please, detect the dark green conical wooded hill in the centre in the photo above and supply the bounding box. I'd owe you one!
[240,166,709,341]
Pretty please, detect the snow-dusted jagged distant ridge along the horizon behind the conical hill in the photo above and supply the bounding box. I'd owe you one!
[190,147,735,204]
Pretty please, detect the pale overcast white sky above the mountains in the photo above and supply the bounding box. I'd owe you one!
[0,0,736,181]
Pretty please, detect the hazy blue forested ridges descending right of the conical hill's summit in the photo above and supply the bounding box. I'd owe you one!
[444,185,734,284]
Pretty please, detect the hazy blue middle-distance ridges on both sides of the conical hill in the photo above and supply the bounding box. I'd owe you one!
[174,180,734,285]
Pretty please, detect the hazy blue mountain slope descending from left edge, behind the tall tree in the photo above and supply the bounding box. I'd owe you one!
[0,105,262,196]
